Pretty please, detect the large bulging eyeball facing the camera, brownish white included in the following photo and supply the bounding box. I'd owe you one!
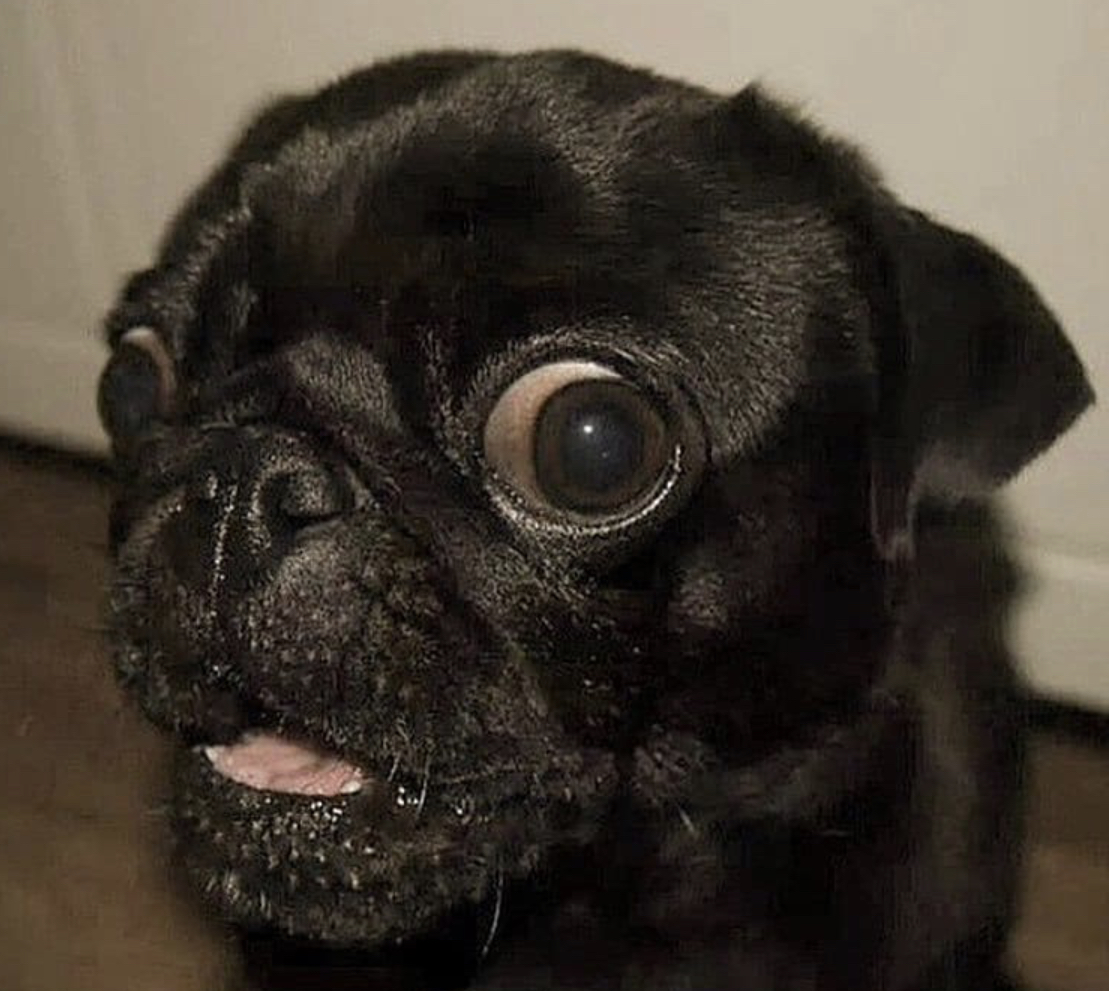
[485,361,675,517]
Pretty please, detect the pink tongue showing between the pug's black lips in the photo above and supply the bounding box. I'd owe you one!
[204,733,366,797]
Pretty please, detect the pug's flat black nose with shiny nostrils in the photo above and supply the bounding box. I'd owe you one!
[164,431,354,591]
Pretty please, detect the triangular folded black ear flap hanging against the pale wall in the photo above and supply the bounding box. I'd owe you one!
[871,206,1093,560]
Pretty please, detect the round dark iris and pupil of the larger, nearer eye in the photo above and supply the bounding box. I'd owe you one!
[535,380,664,511]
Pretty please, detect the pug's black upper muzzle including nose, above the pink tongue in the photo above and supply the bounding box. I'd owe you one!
[112,416,607,788]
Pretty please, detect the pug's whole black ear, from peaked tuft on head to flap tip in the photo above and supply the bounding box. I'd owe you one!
[704,85,1093,561]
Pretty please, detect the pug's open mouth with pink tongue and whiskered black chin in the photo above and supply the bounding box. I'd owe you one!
[166,678,615,952]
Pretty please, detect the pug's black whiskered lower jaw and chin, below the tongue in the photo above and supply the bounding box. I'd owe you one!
[175,727,614,948]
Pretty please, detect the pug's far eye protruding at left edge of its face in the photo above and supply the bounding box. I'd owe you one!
[98,327,176,440]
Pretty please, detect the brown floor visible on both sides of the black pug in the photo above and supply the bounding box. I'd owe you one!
[0,448,1109,991]
